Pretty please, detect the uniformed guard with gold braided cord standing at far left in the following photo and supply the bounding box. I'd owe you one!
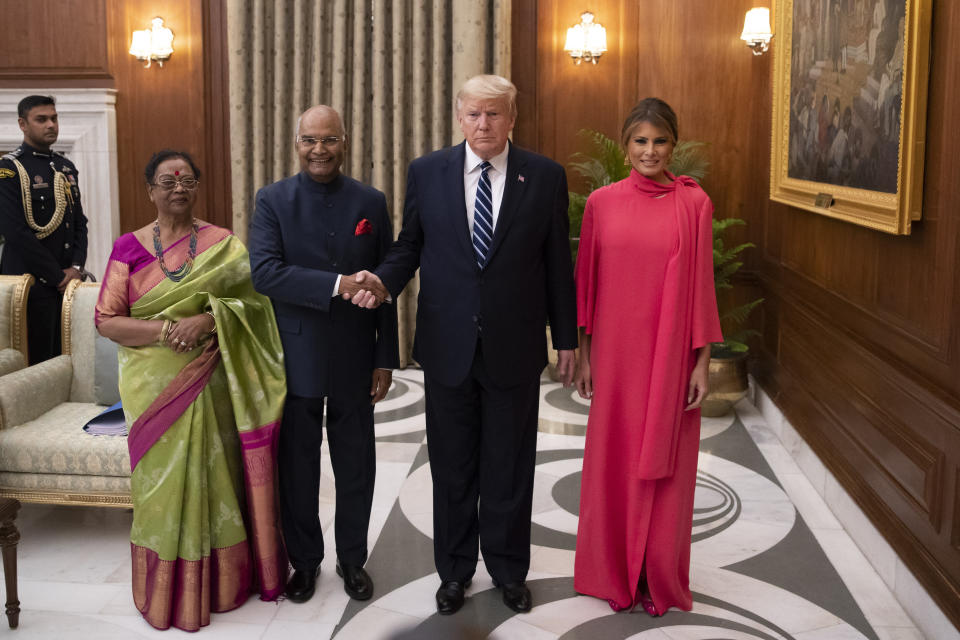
[0,96,87,364]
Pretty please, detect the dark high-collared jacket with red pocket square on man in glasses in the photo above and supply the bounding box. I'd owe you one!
[250,173,399,401]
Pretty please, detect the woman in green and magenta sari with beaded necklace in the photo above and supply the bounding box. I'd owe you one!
[96,151,287,631]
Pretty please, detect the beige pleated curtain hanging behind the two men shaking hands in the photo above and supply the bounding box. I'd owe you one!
[227,0,510,366]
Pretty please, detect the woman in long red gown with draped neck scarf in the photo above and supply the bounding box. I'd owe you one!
[574,98,723,615]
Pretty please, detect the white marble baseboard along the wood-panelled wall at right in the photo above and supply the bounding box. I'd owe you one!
[751,380,960,640]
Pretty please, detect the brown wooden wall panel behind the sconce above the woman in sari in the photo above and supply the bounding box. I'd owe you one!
[108,0,210,232]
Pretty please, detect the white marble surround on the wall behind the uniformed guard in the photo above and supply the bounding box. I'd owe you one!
[0,87,120,280]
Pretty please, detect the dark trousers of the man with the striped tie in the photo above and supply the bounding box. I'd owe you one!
[424,349,540,583]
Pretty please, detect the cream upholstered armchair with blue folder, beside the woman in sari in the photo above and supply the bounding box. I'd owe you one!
[0,281,131,507]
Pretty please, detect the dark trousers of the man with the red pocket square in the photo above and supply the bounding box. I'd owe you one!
[277,394,377,571]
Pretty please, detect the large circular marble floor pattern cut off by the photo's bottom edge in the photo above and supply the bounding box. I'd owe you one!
[338,562,866,640]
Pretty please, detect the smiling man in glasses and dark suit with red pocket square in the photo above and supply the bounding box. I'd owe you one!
[250,106,399,602]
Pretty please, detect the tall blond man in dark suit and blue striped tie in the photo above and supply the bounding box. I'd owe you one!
[352,76,577,614]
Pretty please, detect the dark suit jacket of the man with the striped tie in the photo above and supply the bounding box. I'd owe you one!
[376,143,577,386]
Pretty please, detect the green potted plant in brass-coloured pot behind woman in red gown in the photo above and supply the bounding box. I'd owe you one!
[567,129,763,416]
